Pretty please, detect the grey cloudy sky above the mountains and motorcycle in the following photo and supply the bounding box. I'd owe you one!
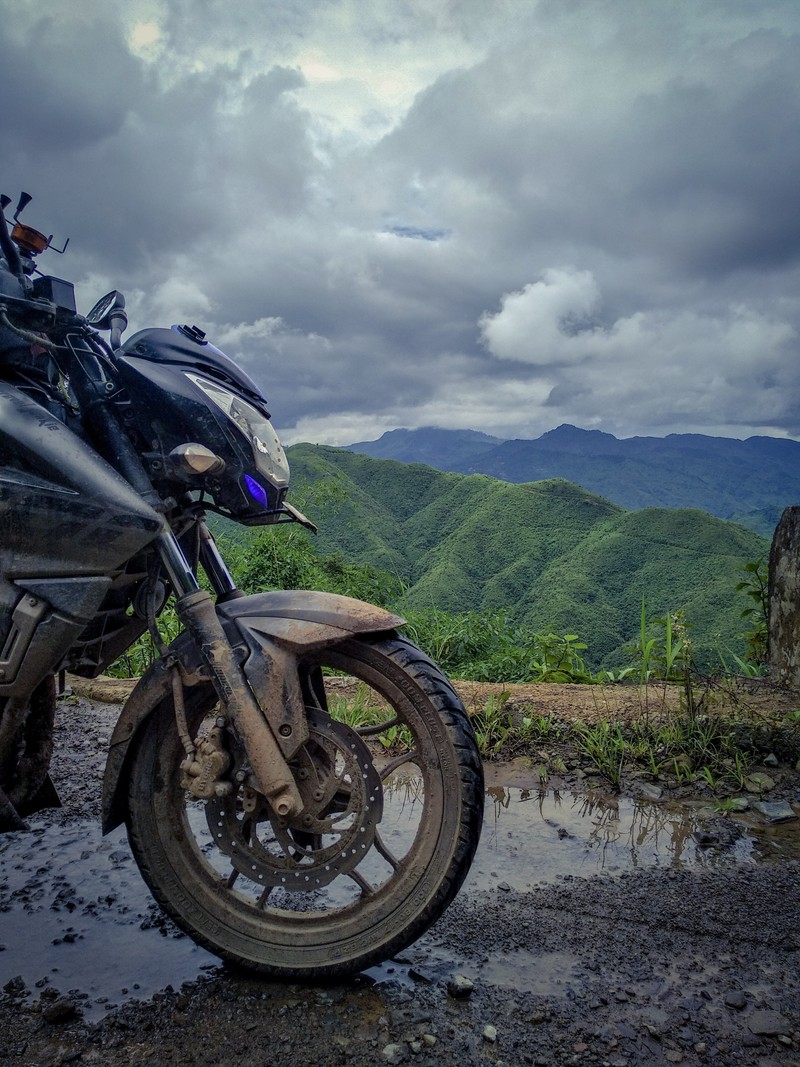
[0,0,800,444]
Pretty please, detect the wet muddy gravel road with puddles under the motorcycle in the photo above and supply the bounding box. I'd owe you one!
[0,698,800,1067]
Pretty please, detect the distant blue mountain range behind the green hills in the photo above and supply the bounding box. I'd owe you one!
[347,424,800,537]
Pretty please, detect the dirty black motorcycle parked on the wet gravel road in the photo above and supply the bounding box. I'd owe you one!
[0,193,483,977]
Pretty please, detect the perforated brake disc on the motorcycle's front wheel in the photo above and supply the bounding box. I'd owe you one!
[206,710,383,891]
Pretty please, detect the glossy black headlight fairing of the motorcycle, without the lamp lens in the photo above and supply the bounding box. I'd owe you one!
[116,329,286,524]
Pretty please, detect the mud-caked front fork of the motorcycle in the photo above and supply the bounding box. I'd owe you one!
[157,524,303,818]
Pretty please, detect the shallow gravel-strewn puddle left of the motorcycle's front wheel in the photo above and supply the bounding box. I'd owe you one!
[0,815,220,1019]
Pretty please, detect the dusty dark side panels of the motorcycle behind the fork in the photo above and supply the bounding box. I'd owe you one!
[0,381,163,698]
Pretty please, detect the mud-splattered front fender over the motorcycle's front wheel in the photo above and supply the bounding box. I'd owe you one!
[102,589,405,833]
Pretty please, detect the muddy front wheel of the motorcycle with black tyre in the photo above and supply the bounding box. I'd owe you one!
[128,635,483,977]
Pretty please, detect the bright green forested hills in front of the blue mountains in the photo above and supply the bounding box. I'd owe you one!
[289,445,768,663]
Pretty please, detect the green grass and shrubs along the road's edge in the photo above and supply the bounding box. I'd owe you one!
[108,527,800,811]
